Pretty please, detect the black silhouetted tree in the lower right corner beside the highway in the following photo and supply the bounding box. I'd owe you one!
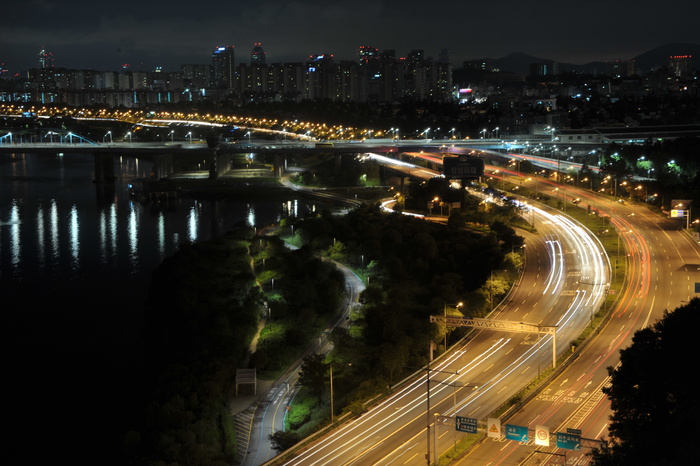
[591,298,700,466]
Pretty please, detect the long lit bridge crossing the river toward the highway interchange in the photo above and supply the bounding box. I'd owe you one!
[0,128,620,186]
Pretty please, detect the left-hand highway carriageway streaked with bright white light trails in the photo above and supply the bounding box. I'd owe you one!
[269,159,609,465]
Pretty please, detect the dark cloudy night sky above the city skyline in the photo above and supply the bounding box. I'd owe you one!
[0,0,700,72]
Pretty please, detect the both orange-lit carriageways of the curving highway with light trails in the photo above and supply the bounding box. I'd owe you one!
[249,147,700,465]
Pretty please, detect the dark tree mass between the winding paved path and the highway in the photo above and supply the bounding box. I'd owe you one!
[288,206,522,418]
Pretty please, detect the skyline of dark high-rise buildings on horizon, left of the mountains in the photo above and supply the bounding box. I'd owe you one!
[6,43,460,107]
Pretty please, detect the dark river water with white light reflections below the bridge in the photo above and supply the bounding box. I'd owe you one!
[0,154,317,464]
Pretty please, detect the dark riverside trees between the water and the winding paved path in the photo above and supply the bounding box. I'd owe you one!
[124,228,343,465]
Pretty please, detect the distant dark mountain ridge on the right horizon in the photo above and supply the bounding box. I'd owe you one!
[486,43,700,75]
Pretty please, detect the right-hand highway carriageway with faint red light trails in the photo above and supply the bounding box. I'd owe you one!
[457,180,700,465]
